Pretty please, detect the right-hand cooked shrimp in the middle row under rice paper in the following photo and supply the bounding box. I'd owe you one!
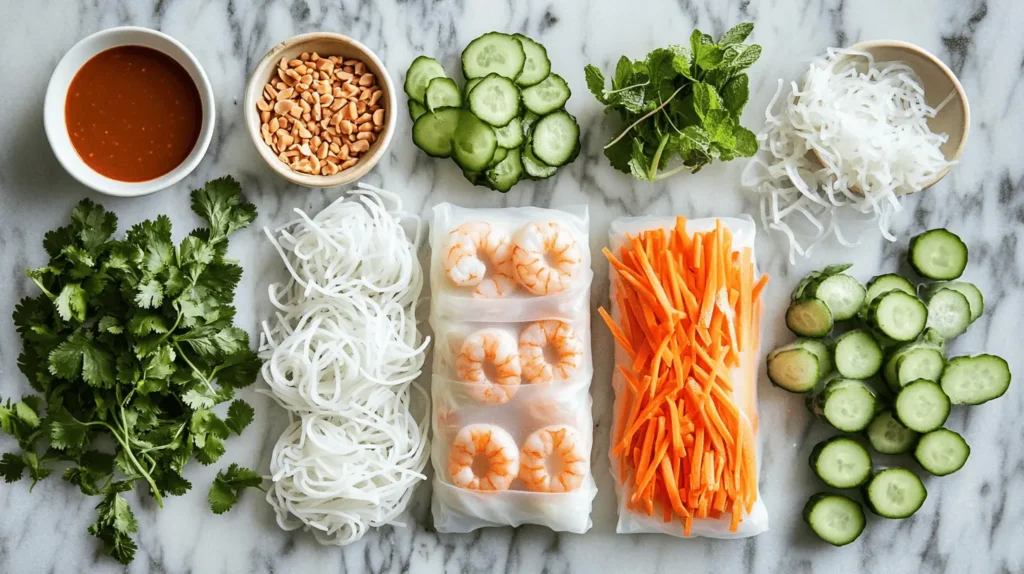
[519,320,583,383]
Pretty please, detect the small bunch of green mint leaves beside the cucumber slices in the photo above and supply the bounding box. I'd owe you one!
[584,23,761,181]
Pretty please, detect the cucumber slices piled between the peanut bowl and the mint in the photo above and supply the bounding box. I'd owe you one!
[406,32,580,191]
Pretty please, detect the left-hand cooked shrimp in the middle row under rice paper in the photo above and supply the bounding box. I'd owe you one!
[456,328,522,404]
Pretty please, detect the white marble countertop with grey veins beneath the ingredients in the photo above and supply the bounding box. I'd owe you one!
[0,0,1024,573]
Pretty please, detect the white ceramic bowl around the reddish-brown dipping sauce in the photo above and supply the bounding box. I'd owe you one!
[43,26,216,197]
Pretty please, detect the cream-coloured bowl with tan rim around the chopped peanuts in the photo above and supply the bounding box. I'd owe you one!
[244,32,398,187]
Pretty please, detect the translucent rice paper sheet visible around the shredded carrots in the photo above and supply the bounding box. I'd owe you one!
[608,216,768,539]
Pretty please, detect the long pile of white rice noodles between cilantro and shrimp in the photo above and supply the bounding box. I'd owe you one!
[260,184,430,545]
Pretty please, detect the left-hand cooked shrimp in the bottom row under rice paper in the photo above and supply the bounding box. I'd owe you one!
[449,425,519,490]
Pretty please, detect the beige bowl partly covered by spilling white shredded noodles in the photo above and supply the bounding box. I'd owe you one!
[814,40,971,189]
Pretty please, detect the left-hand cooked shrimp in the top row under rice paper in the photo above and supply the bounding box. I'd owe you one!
[444,221,515,298]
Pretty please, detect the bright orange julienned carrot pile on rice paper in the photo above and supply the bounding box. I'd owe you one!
[599,217,768,536]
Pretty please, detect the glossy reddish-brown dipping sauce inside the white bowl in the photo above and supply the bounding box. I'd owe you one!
[65,46,203,181]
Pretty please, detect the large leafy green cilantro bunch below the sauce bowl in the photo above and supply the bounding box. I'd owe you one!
[0,177,259,564]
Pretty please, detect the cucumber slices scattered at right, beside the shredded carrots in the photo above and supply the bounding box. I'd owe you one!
[768,229,1011,546]
